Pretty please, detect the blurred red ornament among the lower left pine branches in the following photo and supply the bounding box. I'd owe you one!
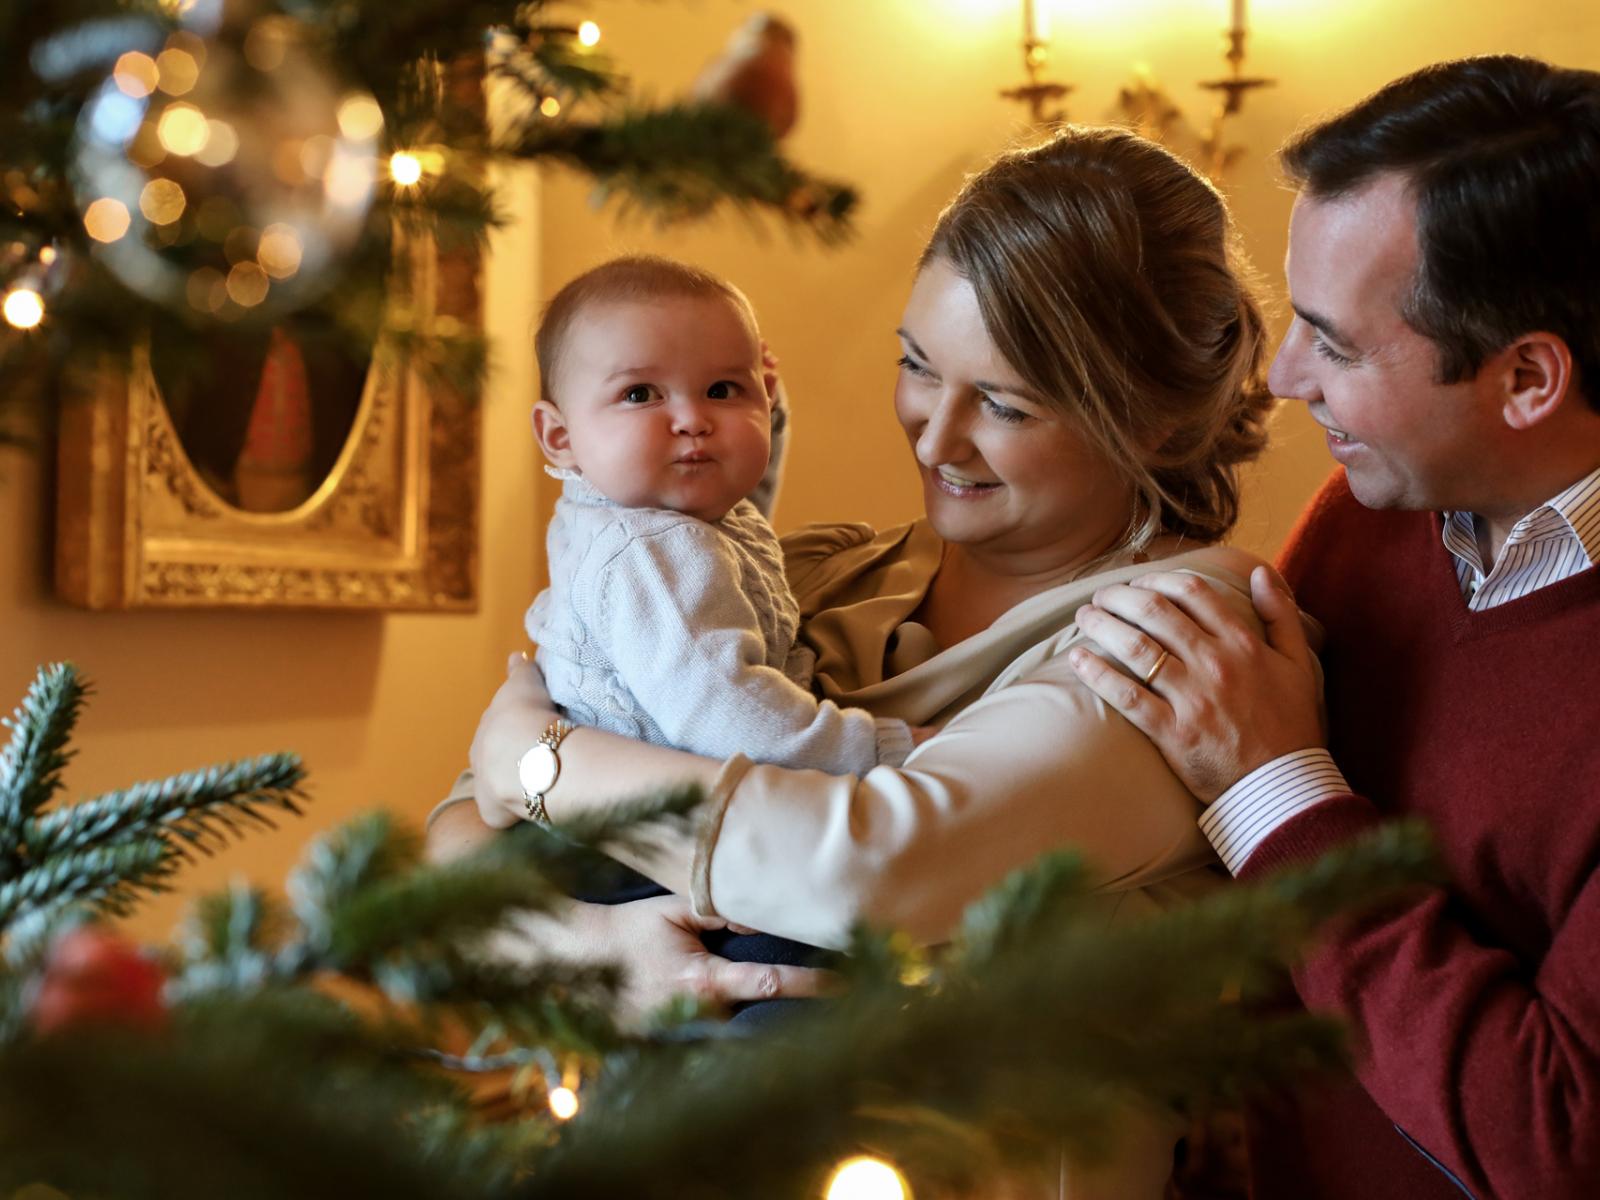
[32,925,166,1034]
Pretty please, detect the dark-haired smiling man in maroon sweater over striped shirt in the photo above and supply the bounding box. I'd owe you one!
[1075,58,1600,1200]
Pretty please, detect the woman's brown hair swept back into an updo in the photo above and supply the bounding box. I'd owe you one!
[918,126,1272,549]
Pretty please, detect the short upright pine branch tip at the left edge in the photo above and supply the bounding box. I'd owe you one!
[0,662,90,844]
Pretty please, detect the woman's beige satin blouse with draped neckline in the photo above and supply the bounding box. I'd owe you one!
[693,522,1259,947]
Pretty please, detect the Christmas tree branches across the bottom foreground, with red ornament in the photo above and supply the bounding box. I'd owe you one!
[0,666,1429,1200]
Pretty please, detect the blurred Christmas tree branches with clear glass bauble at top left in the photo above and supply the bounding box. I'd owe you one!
[0,0,856,438]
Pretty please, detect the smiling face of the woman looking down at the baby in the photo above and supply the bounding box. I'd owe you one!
[894,258,1133,571]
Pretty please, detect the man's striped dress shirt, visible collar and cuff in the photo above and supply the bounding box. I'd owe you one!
[1200,469,1600,874]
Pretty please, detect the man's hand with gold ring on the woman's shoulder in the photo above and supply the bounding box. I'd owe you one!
[1069,566,1325,803]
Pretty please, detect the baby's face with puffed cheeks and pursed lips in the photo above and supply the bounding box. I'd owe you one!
[541,296,771,520]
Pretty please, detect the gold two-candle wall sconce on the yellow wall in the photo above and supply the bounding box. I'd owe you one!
[1000,0,1275,182]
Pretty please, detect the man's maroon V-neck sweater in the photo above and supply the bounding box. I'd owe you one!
[1242,472,1600,1200]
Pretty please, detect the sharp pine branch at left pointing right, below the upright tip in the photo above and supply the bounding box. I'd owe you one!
[22,754,306,862]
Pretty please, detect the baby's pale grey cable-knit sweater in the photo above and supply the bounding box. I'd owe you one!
[526,472,912,774]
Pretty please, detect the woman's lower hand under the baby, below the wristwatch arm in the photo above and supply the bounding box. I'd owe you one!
[493,896,838,1024]
